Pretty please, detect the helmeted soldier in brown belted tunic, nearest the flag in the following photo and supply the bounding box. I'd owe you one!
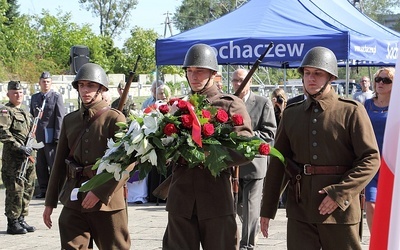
[261,47,379,250]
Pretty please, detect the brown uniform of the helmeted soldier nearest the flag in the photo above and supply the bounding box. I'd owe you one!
[261,89,379,249]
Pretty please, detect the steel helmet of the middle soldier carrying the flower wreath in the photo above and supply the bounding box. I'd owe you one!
[183,43,218,71]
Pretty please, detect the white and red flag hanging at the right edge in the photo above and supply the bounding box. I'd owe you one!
[369,49,400,250]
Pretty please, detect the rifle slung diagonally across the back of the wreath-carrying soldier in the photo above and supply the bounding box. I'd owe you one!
[153,42,274,201]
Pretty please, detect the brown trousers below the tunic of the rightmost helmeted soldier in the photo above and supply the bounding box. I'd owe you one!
[287,219,361,250]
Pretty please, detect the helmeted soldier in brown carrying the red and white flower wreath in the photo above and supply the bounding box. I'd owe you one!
[163,44,253,249]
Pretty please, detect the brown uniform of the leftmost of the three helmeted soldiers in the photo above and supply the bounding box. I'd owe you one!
[45,101,130,249]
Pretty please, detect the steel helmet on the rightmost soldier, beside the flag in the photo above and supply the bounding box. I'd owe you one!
[297,47,338,78]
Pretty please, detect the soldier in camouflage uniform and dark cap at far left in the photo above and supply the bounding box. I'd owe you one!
[0,81,35,234]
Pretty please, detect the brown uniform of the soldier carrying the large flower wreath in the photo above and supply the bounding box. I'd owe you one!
[163,85,252,250]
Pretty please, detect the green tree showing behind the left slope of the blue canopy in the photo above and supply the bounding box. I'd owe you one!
[173,0,236,32]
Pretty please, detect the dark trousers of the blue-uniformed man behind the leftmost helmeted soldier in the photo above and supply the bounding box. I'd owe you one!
[36,143,57,193]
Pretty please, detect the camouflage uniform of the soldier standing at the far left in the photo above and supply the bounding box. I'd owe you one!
[0,102,35,219]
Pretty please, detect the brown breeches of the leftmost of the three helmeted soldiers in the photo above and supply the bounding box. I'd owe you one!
[58,207,131,250]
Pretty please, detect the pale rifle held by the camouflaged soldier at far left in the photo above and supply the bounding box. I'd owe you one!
[18,99,46,181]
